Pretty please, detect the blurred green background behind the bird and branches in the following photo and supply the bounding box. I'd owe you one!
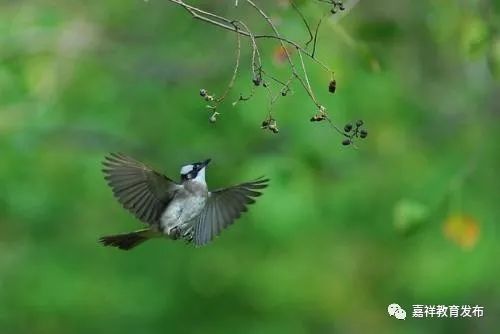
[0,0,500,334]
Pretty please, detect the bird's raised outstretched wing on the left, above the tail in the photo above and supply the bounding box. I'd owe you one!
[102,153,180,225]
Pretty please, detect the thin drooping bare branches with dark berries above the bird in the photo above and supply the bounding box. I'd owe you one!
[162,0,367,146]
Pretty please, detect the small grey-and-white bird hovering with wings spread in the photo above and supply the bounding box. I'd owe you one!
[99,153,269,250]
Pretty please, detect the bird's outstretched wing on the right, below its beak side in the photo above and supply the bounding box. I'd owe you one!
[192,178,269,246]
